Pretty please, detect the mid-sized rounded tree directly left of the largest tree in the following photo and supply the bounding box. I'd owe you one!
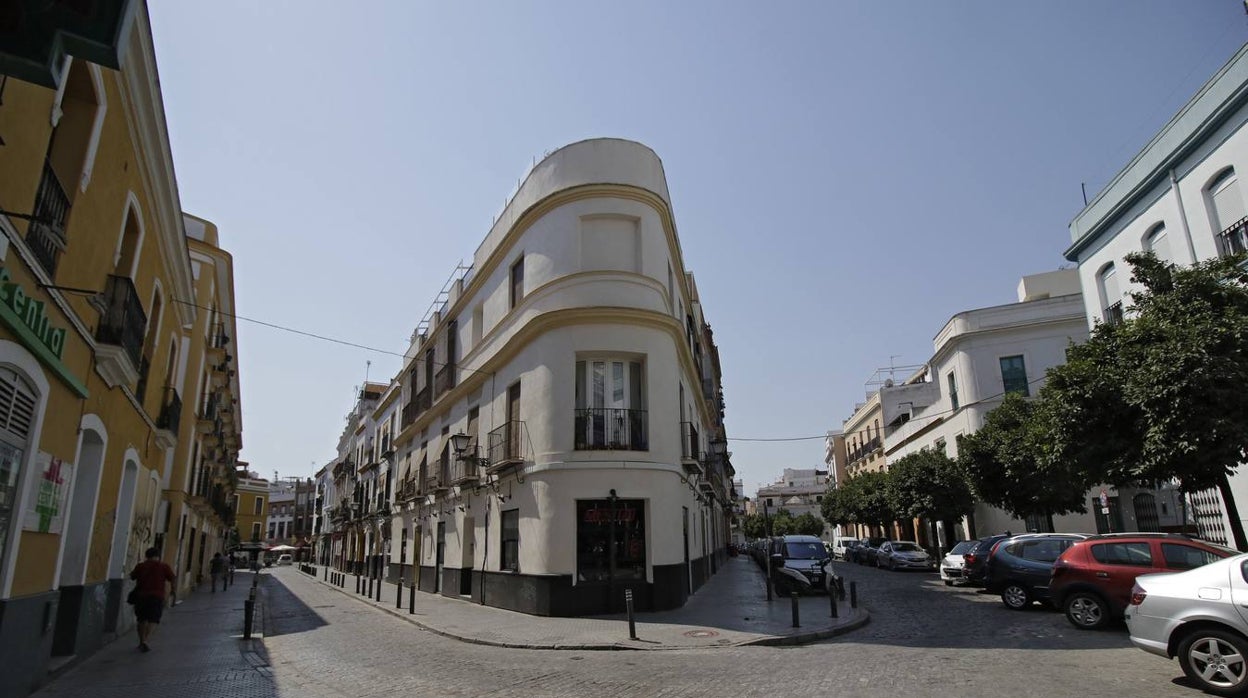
[957,393,1092,529]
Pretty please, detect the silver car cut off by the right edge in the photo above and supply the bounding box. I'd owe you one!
[1124,554,1248,696]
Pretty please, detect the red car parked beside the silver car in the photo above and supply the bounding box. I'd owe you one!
[1050,533,1238,631]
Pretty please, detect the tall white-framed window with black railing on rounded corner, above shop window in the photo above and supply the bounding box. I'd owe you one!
[574,358,649,451]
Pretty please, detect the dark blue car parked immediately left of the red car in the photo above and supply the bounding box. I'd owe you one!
[983,533,1088,611]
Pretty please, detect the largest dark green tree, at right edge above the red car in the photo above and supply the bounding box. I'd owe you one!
[1041,253,1248,549]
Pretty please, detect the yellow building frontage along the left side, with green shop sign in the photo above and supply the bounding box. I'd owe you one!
[0,0,241,696]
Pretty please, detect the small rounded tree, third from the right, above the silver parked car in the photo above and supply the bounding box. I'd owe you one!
[889,448,975,549]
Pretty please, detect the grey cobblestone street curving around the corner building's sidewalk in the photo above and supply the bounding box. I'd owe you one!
[34,563,1201,698]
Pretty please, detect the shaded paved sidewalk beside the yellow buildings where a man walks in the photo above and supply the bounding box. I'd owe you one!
[34,572,277,698]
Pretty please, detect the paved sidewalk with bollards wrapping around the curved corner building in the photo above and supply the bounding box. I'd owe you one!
[302,557,869,649]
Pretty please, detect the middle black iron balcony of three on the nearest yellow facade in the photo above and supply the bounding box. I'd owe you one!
[95,275,147,388]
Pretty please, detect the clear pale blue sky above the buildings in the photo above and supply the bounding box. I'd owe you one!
[150,0,1248,494]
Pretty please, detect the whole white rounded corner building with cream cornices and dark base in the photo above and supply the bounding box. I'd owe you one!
[328,139,736,616]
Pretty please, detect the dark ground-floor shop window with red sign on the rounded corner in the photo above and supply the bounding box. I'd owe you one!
[577,499,645,582]
